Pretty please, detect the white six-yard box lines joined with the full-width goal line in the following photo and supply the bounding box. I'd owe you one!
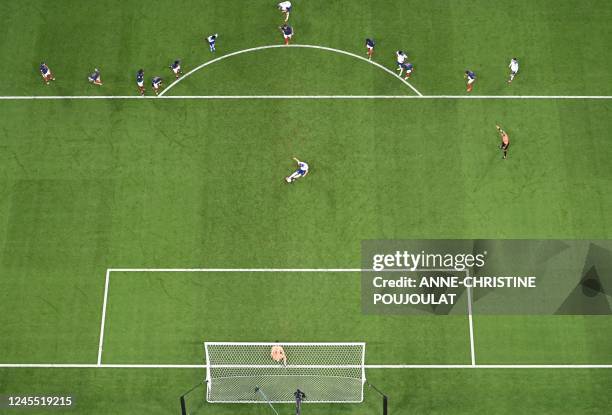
[0,268,612,369]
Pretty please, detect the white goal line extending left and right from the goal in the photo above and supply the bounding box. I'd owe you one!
[0,363,612,369]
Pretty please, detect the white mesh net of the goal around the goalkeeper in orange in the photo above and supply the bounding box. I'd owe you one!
[204,342,366,403]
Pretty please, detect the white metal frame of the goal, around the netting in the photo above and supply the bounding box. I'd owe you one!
[204,342,367,404]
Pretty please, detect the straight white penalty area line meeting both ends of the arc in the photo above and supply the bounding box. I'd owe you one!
[0,95,612,101]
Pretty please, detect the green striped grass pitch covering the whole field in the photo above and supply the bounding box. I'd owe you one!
[0,0,612,415]
